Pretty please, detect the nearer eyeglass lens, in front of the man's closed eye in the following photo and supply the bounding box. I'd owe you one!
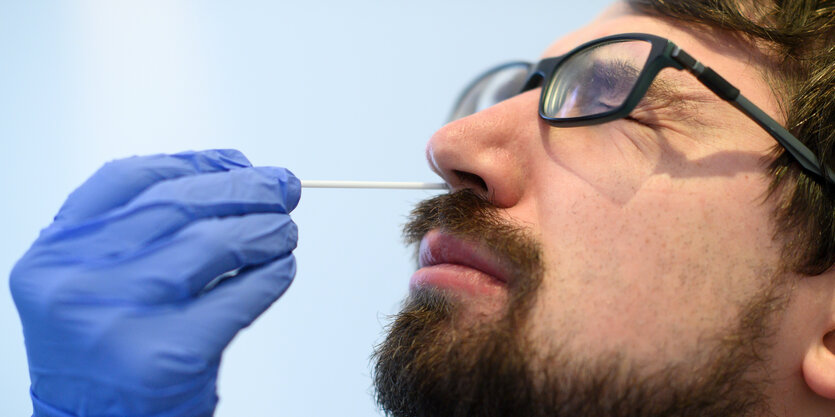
[542,40,652,119]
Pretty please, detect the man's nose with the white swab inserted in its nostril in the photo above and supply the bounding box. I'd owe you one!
[426,90,539,208]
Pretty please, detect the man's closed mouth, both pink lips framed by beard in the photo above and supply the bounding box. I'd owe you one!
[410,229,510,297]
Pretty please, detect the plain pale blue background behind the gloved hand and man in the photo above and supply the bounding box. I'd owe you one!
[0,0,608,416]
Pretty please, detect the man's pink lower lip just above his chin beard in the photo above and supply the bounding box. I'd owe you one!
[410,264,507,297]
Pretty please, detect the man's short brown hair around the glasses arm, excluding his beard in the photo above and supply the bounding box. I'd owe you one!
[627,0,835,275]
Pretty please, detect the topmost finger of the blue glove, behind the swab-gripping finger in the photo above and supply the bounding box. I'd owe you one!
[55,149,252,222]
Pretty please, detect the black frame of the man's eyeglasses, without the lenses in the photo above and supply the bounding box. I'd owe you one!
[456,33,835,185]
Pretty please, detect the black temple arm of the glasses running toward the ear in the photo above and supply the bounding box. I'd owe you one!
[671,46,835,184]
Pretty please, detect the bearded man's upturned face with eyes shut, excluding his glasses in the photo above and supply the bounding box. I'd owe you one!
[376,4,796,416]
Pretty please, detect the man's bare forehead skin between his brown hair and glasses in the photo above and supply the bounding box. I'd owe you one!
[542,1,783,120]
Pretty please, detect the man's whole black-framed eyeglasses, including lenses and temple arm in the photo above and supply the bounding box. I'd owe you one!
[450,33,835,184]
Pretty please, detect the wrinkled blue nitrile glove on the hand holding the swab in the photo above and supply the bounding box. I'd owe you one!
[10,150,301,417]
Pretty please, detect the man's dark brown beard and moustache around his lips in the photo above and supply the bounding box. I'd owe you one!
[372,190,787,417]
